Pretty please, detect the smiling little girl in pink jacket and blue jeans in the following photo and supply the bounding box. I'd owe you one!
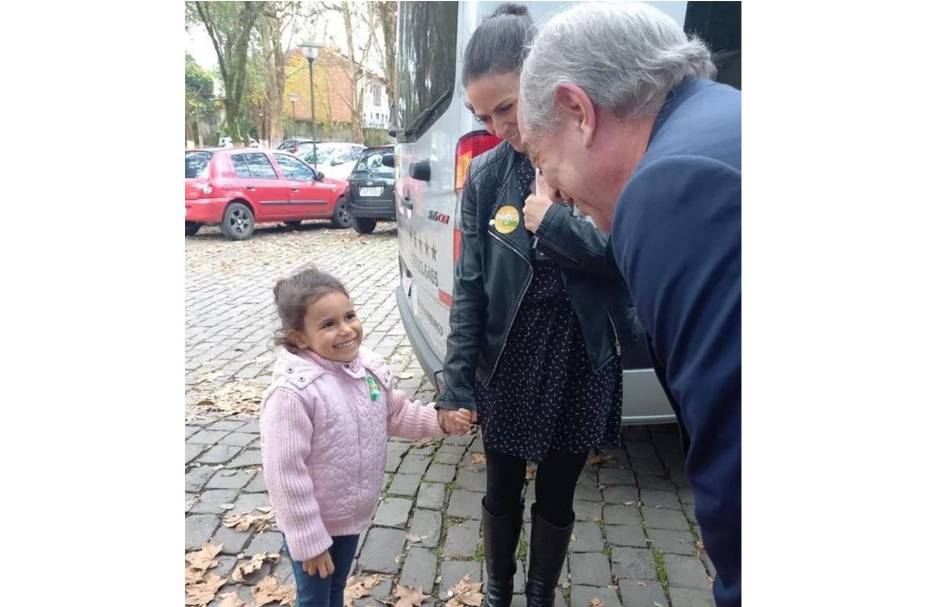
[261,268,470,607]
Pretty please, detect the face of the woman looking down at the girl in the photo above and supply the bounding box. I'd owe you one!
[467,72,524,152]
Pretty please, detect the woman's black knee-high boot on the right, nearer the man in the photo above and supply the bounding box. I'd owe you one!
[525,505,575,607]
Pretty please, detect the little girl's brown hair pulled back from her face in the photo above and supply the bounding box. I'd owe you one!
[274,266,350,351]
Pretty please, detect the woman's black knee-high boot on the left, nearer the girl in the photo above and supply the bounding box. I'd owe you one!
[483,503,523,607]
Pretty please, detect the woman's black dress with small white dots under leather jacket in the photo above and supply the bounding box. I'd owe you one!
[476,157,622,462]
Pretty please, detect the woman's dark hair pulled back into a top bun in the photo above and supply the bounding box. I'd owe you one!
[463,2,534,86]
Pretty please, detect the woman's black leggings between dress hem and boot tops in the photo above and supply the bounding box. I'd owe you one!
[484,449,589,527]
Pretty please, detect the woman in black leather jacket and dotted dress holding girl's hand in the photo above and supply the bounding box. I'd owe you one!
[437,4,625,607]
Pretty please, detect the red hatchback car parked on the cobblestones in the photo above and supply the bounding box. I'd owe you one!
[186,148,351,240]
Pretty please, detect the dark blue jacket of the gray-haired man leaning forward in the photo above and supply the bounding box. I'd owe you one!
[611,79,741,607]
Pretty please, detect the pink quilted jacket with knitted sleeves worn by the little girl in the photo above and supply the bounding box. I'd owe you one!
[261,348,444,561]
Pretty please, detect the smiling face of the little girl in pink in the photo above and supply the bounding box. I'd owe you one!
[293,291,364,362]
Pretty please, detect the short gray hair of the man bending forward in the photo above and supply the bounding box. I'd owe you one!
[521,2,717,130]
